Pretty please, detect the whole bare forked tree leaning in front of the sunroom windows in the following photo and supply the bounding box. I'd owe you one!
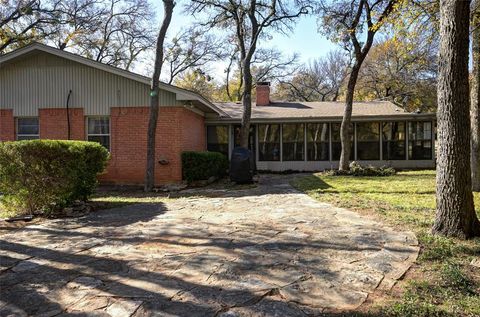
[319,0,399,170]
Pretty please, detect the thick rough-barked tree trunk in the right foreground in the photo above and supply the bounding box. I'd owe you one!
[432,0,480,239]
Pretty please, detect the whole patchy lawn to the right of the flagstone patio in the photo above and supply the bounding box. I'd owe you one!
[292,171,480,317]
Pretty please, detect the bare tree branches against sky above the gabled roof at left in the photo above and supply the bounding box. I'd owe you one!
[0,0,155,69]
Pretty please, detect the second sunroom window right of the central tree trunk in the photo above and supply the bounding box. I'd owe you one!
[282,123,305,161]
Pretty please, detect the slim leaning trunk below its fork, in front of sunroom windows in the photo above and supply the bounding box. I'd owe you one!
[338,59,363,171]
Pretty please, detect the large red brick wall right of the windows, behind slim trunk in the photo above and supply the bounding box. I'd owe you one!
[101,107,205,184]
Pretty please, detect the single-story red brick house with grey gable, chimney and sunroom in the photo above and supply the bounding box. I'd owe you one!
[0,43,435,184]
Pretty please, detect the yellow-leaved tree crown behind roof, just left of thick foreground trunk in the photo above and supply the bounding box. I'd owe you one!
[355,33,438,111]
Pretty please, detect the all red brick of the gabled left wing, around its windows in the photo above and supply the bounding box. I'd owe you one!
[0,107,206,184]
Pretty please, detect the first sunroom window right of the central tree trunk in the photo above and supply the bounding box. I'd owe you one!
[258,124,280,161]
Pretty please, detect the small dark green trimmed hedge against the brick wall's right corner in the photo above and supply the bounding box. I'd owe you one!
[182,152,228,182]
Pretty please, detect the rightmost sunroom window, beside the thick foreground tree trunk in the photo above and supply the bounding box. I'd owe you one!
[408,121,432,160]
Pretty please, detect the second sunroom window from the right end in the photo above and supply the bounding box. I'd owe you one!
[382,122,406,160]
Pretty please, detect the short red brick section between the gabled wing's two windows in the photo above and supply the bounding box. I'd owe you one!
[38,108,85,140]
